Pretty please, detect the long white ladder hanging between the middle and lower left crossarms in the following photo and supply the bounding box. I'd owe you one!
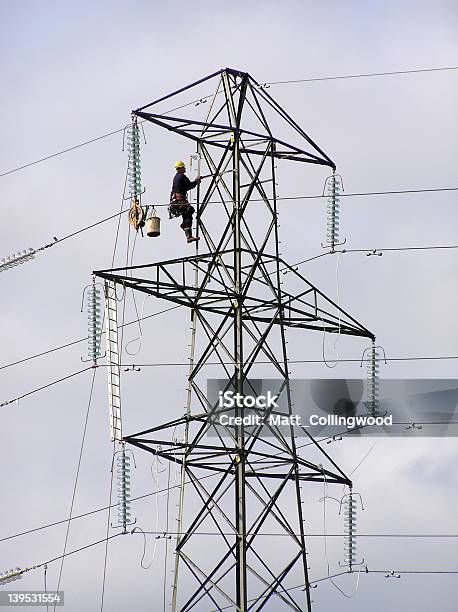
[105,281,122,442]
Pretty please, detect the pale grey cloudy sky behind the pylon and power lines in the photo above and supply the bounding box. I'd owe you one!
[0,0,458,612]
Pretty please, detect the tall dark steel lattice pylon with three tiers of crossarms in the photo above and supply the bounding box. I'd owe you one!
[95,68,374,612]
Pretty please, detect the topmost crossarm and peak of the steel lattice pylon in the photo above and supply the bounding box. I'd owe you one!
[132,68,336,169]
